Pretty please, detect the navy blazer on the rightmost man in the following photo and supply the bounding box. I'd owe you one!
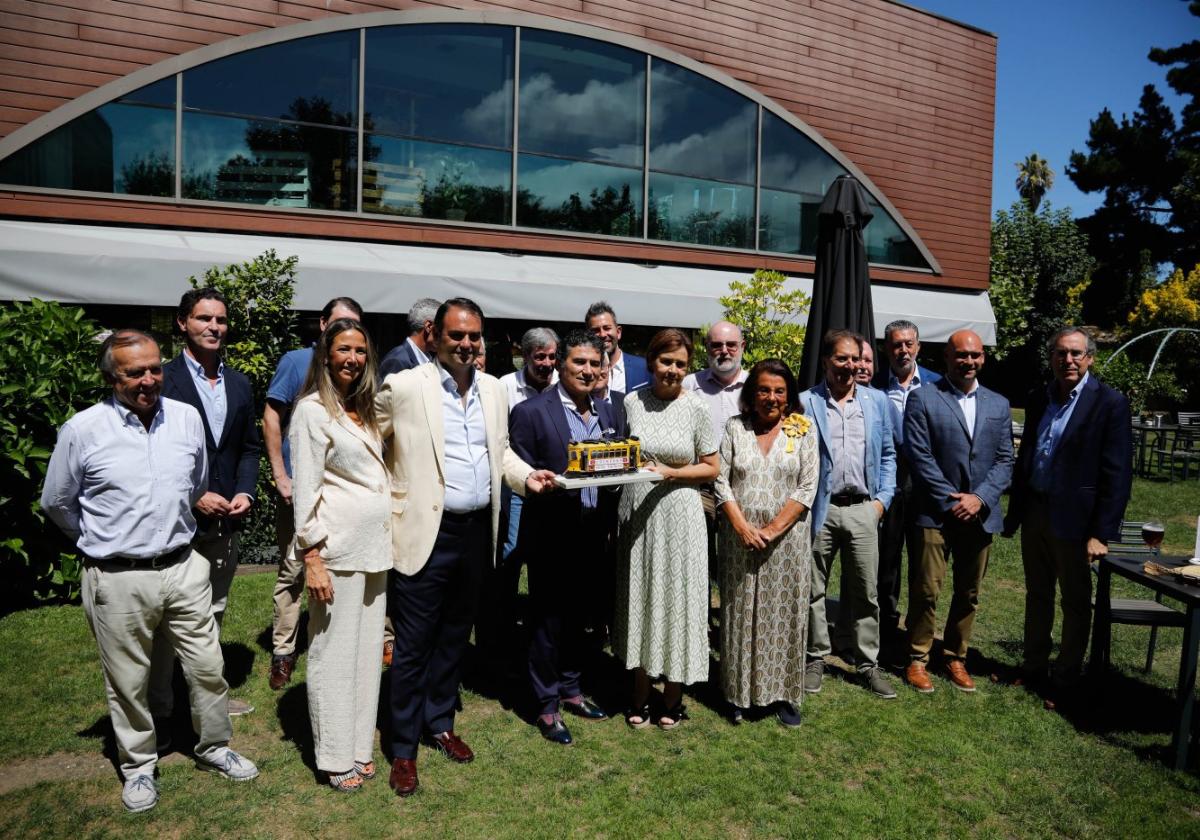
[1004,373,1133,542]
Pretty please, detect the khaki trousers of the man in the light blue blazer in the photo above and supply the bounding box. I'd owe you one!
[808,502,880,671]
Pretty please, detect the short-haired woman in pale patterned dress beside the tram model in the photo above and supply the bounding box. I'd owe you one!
[613,330,716,730]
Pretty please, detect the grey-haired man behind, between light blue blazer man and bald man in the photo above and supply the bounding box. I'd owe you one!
[871,319,942,648]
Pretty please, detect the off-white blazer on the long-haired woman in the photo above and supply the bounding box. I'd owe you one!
[288,394,391,571]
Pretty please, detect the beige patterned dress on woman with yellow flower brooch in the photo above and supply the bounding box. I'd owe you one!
[716,415,818,708]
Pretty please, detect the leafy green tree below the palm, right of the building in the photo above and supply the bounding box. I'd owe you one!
[989,200,1093,370]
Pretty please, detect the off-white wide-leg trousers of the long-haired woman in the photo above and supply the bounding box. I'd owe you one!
[307,570,388,773]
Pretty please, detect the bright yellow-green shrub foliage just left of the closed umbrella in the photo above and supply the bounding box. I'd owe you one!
[692,269,812,371]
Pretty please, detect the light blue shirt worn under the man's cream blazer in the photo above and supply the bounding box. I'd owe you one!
[434,362,492,514]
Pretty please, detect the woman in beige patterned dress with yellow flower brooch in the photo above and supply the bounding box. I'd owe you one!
[716,359,818,726]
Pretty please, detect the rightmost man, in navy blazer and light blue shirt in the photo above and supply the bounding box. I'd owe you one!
[1004,326,1133,690]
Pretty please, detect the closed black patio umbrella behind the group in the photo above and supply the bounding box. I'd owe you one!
[798,175,875,388]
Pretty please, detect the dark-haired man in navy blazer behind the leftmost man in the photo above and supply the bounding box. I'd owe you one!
[149,288,263,720]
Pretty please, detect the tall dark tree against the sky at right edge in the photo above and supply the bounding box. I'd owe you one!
[1067,1,1200,326]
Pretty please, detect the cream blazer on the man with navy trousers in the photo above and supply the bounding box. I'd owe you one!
[376,362,533,575]
